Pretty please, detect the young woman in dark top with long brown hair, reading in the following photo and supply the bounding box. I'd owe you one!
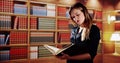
[58,3,100,63]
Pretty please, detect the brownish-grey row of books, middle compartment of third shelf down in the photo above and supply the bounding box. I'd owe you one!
[30,32,55,43]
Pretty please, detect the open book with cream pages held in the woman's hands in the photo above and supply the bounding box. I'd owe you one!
[44,44,74,56]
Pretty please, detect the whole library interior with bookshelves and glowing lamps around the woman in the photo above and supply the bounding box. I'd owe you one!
[0,0,120,63]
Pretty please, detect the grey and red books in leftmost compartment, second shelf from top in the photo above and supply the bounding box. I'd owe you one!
[0,15,28,29]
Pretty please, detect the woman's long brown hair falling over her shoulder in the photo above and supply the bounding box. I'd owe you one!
[69,2,92,39]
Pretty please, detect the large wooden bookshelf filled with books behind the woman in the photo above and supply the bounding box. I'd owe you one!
[0,0,102,63]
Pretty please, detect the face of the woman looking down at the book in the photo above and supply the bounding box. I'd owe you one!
[71,9,85,26]
